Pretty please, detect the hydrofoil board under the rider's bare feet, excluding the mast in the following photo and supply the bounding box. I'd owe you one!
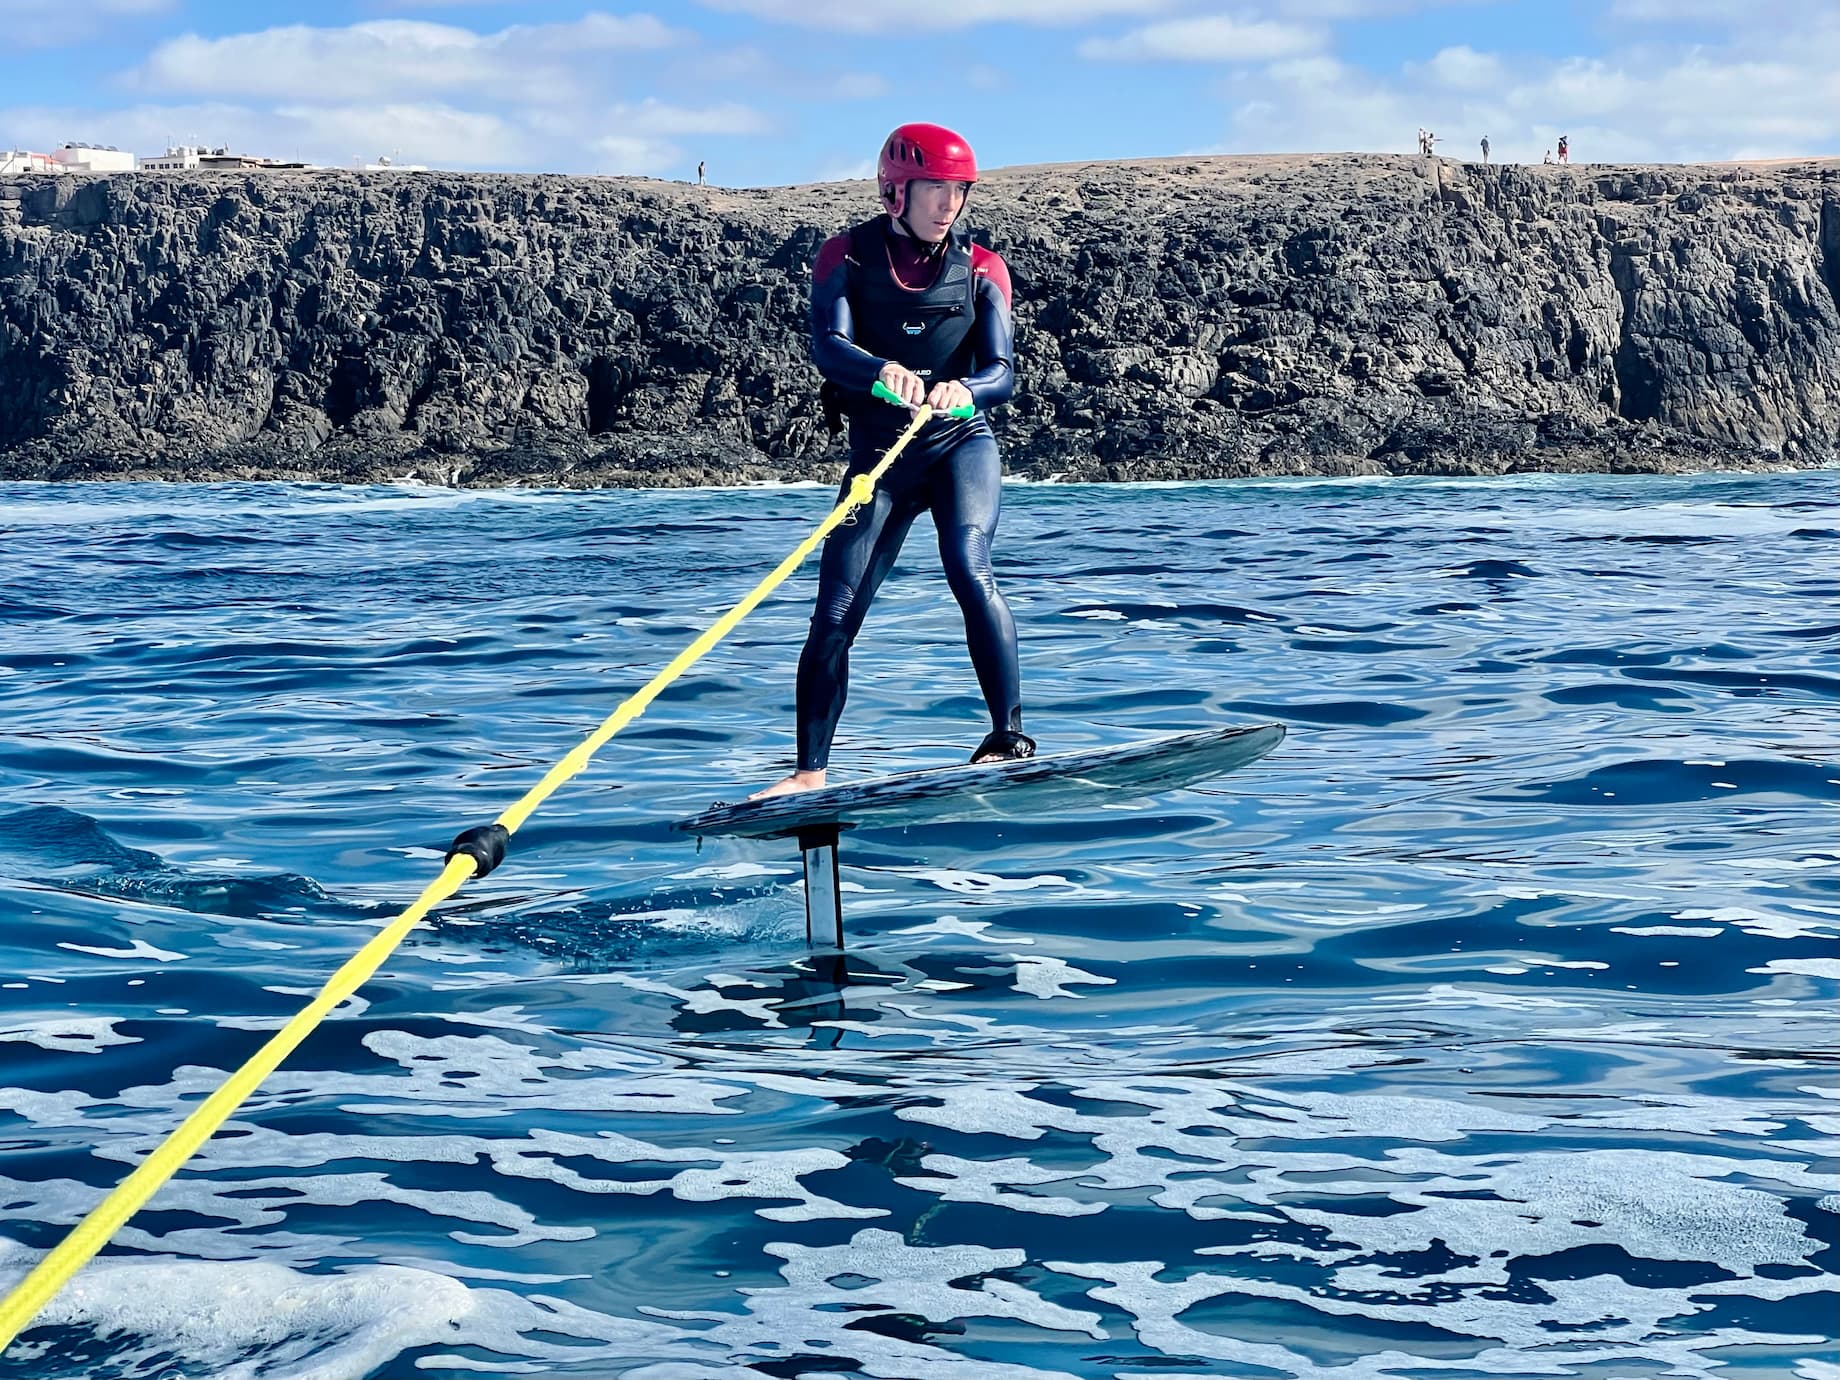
[672,723,1284,839]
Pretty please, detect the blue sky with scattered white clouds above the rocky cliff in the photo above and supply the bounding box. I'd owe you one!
[0,0,1840,186]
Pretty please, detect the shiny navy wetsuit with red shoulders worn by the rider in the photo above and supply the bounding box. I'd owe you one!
[799,217,1023,771]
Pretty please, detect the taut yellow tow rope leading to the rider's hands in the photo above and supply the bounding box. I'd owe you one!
[0,407,933,1351]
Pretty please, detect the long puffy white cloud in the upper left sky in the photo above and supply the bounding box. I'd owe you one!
[129,13,690,101]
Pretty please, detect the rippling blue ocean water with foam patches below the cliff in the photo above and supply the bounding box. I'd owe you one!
[0,473,1840,1380]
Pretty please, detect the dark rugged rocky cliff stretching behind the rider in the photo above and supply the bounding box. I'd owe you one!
[0,155,1840,484]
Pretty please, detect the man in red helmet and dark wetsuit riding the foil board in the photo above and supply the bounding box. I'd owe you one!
[753,125,1036,799]
